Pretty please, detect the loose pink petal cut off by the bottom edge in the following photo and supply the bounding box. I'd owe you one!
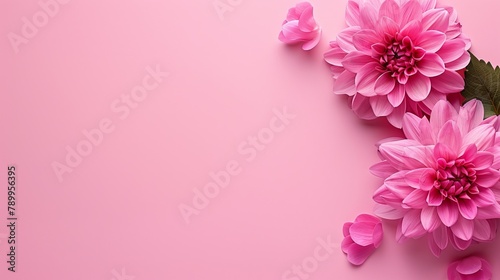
[448,256,493,280]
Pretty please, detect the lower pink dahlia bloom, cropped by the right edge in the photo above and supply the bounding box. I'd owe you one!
[371,100,500,256]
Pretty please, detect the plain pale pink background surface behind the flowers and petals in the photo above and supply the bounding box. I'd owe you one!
[0,0,500,280]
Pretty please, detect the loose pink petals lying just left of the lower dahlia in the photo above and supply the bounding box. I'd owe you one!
[341,214,383,265]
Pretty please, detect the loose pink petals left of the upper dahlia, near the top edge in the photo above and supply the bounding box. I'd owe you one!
[279,2,321,51]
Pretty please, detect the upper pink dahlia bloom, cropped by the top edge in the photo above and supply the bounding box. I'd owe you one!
[325,0,470,128]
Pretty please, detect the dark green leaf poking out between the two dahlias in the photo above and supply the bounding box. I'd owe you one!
[462,53,500,117]
